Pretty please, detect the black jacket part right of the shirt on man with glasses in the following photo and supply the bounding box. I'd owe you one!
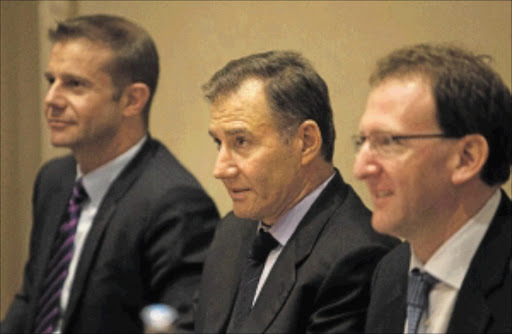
[448,191,512,333]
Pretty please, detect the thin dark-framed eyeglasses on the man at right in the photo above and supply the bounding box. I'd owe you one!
[352,132,458,156]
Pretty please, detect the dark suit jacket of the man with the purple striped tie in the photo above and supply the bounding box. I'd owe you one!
[1,139,218,333]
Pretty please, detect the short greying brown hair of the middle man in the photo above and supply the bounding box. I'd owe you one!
[202,51,336,162]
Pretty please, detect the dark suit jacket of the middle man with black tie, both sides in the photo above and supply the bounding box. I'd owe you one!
[196,172,397,333]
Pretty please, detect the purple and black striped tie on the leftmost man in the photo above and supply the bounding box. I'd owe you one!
[34,179,87,333]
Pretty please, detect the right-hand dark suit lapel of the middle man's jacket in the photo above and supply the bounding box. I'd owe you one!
[241,171,348,333]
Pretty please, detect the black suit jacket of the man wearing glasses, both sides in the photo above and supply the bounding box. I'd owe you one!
[366,192,512,333]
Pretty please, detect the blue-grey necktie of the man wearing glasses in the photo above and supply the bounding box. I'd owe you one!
[407,268,438,334]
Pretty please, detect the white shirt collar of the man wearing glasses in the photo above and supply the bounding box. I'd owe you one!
[409,190,501,290]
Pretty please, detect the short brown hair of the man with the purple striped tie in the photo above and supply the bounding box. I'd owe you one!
[48,15,160,126]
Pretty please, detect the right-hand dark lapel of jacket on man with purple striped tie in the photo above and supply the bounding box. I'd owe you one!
[63,138,158,332]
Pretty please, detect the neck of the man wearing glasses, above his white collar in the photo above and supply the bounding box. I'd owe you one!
[409,181,499,263]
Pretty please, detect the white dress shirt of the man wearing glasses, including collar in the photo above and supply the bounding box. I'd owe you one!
[404,190,501,333]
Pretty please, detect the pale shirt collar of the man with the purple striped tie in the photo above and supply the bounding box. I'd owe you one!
[77,135,147,206]
